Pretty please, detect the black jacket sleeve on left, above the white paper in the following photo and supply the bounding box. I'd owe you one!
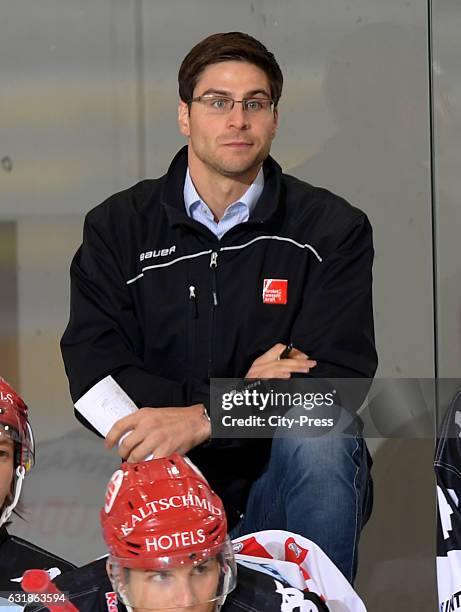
[61,213,187,416]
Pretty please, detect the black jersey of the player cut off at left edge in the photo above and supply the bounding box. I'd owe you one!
[0,526,75,596]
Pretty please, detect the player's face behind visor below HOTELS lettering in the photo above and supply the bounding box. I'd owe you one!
[122,559,220,612]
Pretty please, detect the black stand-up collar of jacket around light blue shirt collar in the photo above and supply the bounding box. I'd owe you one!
[162,145,282,227]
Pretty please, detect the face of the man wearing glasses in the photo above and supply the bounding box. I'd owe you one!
[178,61,278,181]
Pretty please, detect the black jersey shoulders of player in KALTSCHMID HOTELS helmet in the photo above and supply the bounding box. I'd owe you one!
[26,559,328,612]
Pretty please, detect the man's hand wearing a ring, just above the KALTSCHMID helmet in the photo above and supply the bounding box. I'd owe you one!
[104,404,211,462]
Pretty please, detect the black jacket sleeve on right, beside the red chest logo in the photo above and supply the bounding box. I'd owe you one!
[291,213,378,408]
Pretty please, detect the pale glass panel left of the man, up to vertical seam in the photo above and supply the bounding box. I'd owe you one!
[0,0,139,563]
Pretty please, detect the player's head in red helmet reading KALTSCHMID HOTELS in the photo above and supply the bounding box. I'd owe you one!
[101,454,236,612]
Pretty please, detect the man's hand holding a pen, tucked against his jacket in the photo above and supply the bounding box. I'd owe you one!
[245,342,317,378]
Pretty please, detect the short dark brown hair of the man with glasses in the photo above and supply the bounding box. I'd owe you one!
[178,32,283,106]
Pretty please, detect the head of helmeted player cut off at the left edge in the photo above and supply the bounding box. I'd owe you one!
[0,377,34,526]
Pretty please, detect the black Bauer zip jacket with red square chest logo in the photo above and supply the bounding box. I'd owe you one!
[61,147,377,524]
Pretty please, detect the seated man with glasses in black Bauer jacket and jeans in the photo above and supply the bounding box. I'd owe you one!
[61,32,377,580]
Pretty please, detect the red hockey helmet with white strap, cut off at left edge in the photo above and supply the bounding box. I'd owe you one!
[0,377,34,525]
